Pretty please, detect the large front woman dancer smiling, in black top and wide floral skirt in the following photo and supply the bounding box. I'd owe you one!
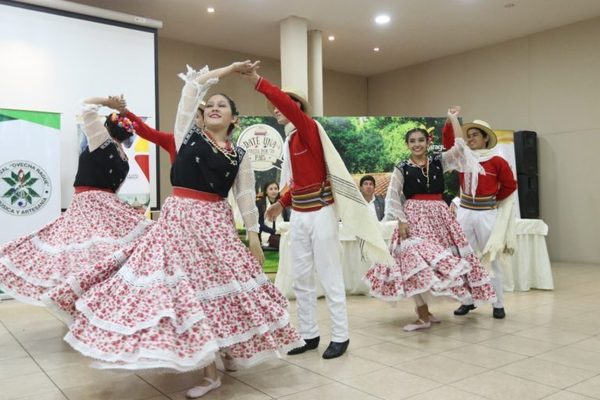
[45,62,304,398]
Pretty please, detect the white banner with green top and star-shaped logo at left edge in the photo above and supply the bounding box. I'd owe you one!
[0,109,60,245]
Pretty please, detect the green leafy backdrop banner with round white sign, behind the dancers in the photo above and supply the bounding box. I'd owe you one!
[234,116,458,195]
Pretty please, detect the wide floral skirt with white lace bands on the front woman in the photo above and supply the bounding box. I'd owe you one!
[51,197,304,371]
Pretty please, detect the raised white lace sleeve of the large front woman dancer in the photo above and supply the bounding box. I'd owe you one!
[174,65,219,150]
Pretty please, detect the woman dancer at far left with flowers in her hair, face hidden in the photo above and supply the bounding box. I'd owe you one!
[0,97,151,305]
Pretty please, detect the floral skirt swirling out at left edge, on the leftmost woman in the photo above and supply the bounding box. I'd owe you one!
[0,190,152,305]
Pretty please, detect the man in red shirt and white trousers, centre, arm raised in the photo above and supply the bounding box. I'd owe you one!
[241,72,350,359]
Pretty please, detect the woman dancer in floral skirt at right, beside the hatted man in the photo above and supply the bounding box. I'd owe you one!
[364,109,495,331]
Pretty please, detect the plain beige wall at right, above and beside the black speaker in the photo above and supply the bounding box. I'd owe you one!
[368,18,600,264]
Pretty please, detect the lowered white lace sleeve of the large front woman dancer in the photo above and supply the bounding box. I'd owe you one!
[231,155,259,233]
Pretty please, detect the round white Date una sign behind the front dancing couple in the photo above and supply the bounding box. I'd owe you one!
[237,124,283,171]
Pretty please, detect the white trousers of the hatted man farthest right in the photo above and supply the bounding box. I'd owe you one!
[456,207,504,308]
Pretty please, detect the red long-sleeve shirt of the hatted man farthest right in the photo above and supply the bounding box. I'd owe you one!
[442,121,517,201]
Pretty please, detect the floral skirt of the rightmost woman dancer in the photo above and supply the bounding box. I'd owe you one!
[364,200,496,303]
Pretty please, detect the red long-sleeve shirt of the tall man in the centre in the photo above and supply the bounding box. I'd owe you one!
[255,78,327,211]
